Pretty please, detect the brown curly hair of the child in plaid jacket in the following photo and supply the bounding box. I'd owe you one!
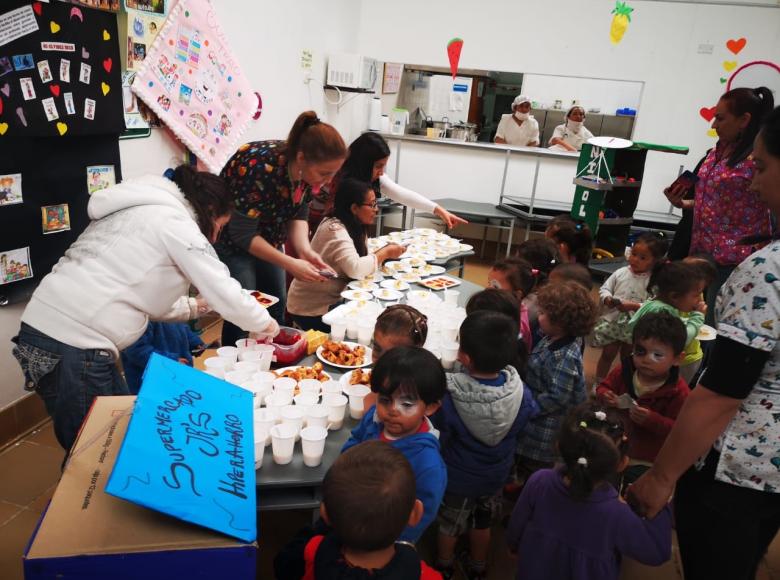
[537,280,598,336]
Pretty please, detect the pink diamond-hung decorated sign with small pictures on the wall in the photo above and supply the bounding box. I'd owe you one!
[132,0,258,173]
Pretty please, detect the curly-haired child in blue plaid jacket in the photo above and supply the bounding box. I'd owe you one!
[517,282,596,483]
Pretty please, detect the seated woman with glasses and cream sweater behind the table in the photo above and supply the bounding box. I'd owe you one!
[287,178,405,332]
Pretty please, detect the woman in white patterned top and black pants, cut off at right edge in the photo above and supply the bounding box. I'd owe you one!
[629,108,780,580]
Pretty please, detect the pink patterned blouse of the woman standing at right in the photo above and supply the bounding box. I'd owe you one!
[690,143,770,266]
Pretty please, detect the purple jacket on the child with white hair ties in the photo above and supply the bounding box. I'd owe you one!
[506,469,672,580]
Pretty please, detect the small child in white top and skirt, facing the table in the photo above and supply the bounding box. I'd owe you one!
[592,233,668,383]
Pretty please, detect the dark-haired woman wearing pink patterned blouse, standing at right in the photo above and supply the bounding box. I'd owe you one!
[664,87,774,324]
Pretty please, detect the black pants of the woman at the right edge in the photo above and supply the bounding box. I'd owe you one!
[674,452,780,580]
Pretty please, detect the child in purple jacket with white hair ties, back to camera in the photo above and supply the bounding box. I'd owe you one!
[506,403,672,580]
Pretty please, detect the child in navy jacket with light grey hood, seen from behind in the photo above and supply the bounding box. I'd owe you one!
[433,310,538,578]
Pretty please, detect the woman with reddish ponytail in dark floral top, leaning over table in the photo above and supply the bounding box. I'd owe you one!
[216,111,347,344]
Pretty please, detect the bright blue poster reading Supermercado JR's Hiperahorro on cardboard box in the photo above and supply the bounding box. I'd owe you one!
[106,354,257,542]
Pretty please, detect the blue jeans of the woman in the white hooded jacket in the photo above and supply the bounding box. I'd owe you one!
[12,323,130,451]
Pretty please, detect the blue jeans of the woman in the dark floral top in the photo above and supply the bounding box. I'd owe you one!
[214,244,287,346]
